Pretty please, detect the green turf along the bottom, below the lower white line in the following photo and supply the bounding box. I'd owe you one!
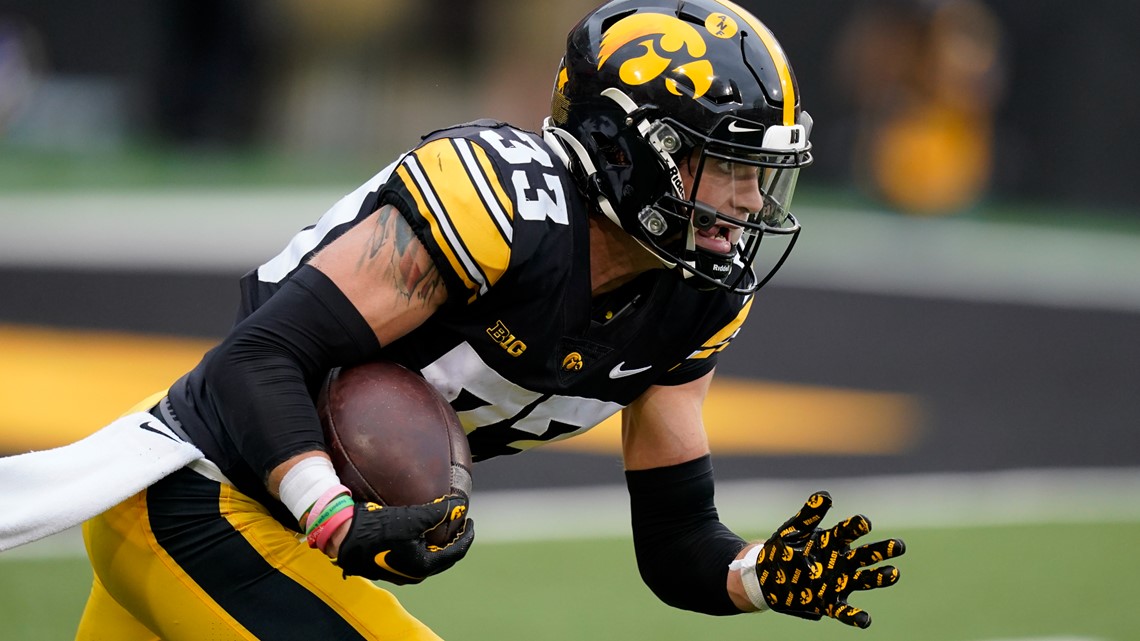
[0,522,1140,641]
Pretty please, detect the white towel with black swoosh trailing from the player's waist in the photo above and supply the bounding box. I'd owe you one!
[0,412,203,552]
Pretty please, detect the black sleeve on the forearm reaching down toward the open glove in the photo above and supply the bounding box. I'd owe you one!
[626,455,747,615]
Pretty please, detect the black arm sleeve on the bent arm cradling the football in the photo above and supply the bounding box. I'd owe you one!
[205,266,380,481]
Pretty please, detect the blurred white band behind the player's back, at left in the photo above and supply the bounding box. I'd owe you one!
[0,189,344,273]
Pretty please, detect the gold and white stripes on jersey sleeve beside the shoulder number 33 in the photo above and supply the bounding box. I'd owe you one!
[415,139,511,293]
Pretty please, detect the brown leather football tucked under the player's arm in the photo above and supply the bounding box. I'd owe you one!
[317,362,471,545]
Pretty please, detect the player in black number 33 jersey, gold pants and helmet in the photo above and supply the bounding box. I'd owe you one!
[79,0,903,641]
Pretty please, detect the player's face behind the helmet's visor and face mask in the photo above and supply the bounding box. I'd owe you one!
[681,153,772,254]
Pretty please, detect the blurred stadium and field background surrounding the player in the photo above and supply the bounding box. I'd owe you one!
[0,0,1140,641]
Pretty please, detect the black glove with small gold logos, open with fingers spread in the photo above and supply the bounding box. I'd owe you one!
[756,492,906,627]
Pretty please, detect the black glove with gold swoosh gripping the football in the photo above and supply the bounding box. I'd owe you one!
[336,496,475,585]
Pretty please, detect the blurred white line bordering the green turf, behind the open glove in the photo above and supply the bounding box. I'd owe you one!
[0,469,1140,558]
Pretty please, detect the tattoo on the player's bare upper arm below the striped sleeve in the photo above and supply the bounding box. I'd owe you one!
[357,205,443,302]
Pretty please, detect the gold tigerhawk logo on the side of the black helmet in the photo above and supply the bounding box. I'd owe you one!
[597,14,720,99]
